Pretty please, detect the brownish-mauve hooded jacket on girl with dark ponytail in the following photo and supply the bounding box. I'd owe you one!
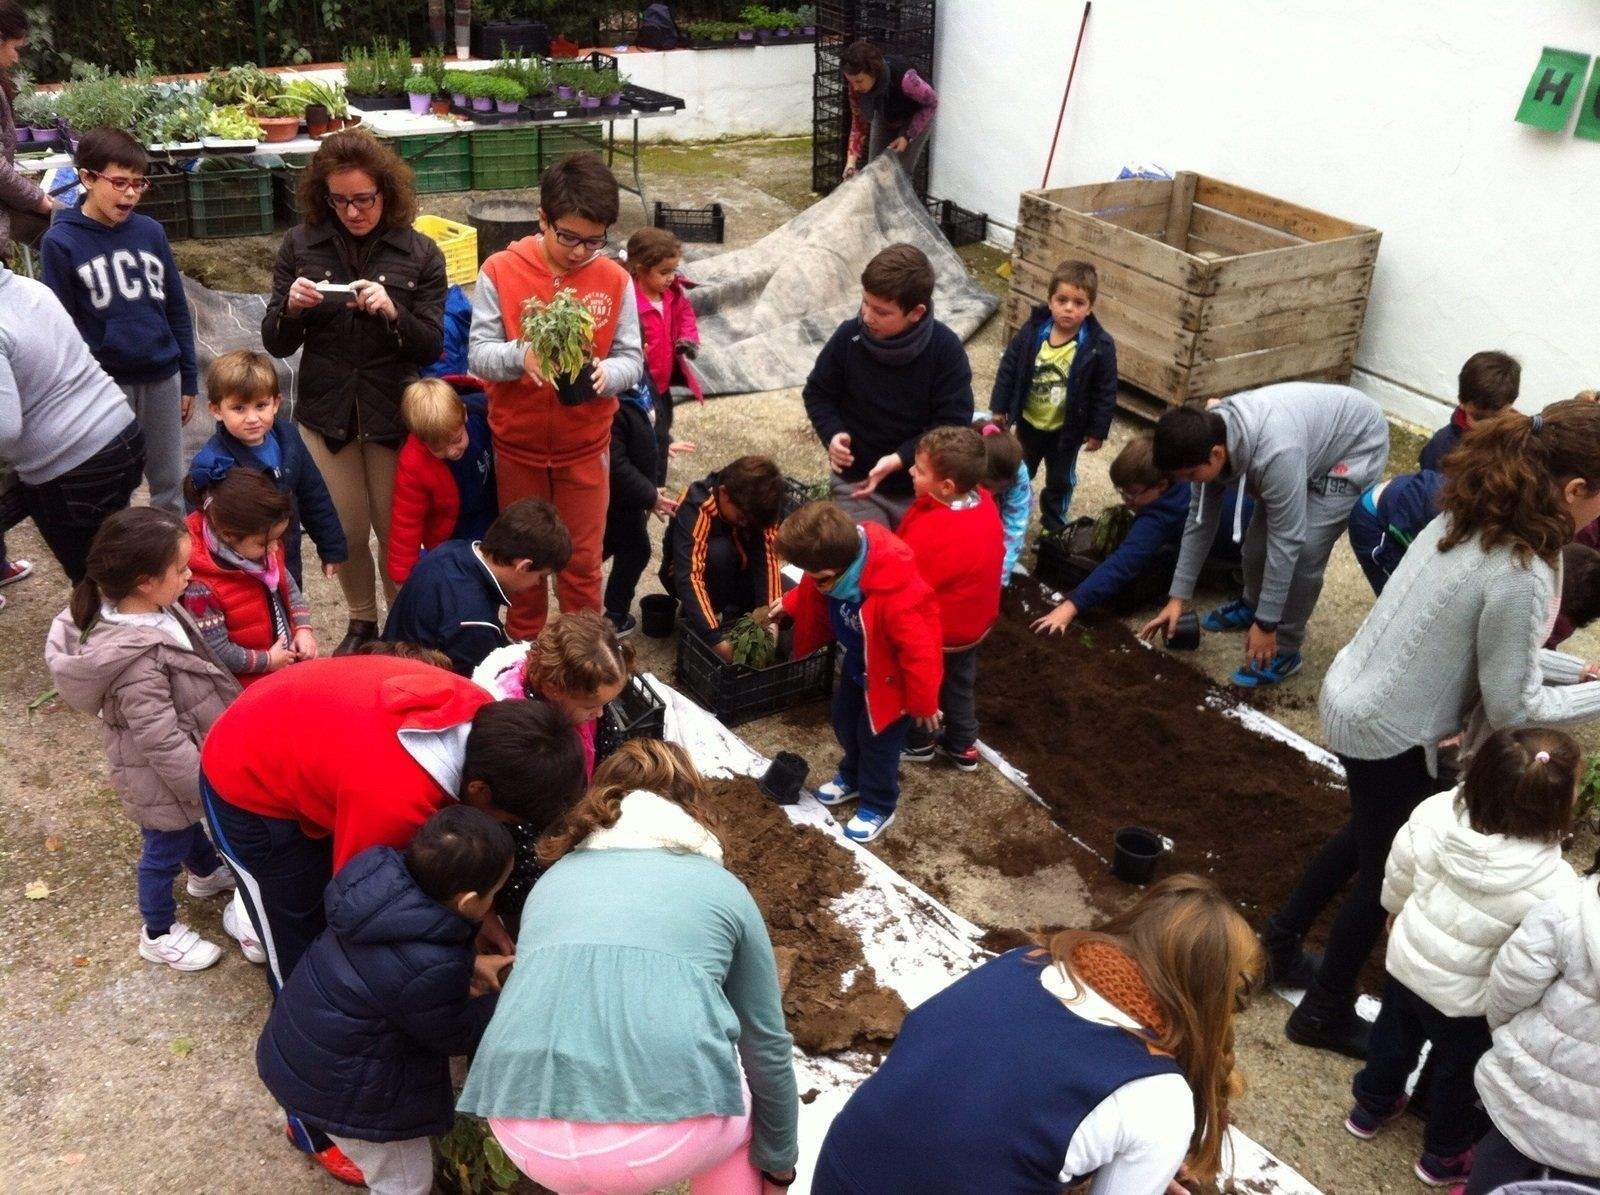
[45,606,238,830]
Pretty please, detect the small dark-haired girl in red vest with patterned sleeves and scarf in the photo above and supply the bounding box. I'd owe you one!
[184,469,317,688]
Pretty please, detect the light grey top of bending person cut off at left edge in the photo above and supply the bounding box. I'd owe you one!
[0,266,133,485]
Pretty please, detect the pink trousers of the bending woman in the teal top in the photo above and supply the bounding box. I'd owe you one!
[490,1112,762,1195]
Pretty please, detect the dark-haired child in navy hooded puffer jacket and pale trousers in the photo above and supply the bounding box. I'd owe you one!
[256,805,512,1195]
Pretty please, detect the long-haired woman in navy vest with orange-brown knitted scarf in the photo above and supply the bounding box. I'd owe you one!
[811,875,1262,1195]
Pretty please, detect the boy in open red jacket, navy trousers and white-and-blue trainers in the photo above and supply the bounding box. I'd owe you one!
[770,502,944,843]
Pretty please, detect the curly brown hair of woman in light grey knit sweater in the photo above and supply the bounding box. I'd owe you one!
[1438,398,1600,566]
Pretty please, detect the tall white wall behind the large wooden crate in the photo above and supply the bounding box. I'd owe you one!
[931,0,1600,426]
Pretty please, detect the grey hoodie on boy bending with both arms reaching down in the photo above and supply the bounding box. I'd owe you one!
[1168,382,1389,622]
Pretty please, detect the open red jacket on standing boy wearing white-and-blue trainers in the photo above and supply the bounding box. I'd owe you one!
[784,523,940,734]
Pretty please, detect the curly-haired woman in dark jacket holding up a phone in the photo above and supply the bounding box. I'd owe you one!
[261,130,446,654]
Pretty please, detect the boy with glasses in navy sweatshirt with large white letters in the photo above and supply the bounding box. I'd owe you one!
[40,128,198,514]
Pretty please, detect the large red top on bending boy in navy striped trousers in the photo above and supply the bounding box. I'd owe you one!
[200,656,494,872]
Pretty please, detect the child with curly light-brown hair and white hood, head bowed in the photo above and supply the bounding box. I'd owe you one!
[491,609,634,779]
